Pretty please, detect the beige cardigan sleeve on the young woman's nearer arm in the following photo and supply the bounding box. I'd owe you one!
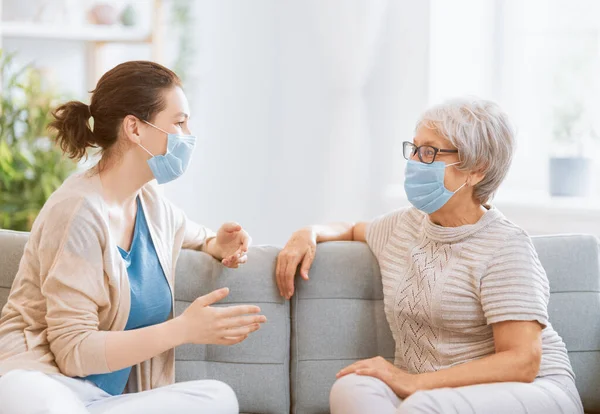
[38,199,110,377]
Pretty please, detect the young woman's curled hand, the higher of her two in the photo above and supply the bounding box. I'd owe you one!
[206,223,252,269]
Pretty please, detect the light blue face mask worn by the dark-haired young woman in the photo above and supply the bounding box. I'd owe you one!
[138,121,196,184]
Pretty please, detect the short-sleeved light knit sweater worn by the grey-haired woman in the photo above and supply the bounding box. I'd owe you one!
[367,208,574,377]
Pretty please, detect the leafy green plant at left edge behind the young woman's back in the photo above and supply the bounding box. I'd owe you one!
[0,49,77,231]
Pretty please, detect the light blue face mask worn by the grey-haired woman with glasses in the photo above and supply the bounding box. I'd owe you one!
[404,160,467,214]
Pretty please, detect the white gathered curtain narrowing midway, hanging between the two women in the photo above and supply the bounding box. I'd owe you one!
[306,0,388,220]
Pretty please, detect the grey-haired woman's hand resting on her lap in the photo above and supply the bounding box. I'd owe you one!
[337,357,419,398]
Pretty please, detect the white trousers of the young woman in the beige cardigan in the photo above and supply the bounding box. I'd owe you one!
[0,370,239,414]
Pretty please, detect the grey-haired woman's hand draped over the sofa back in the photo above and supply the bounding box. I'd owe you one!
[275,227,317,299]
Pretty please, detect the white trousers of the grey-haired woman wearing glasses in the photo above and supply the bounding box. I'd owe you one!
[330,374,583,414]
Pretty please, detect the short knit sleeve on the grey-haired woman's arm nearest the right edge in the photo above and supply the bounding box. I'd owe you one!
[480,232,550,327]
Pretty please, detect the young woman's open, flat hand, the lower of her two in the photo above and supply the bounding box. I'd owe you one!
[176,288,267,345]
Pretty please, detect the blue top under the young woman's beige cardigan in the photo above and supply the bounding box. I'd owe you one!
[83,197,172,395]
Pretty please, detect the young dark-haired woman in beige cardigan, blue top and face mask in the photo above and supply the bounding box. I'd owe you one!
[0,61,266,414]
